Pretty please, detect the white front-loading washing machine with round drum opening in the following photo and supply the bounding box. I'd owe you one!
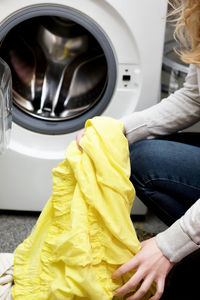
[0,0,167,214]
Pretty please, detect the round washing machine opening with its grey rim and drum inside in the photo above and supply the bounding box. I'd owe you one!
[0,14,116,135]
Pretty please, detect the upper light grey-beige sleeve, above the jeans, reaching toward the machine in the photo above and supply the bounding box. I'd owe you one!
[121,65,200,144]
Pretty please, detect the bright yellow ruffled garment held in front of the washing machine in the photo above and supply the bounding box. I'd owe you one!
[12,117,154,300]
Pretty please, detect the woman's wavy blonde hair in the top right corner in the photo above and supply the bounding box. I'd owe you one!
[168,0,200,65]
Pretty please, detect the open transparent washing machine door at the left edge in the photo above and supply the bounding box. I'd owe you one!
[0,58,12,154]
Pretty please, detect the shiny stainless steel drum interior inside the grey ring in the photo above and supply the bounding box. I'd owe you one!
[0,16,108,127]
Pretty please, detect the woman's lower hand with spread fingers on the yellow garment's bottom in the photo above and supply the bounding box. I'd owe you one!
[112,238,174,300]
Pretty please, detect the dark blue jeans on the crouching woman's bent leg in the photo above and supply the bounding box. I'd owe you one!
[130,133,200,225]
